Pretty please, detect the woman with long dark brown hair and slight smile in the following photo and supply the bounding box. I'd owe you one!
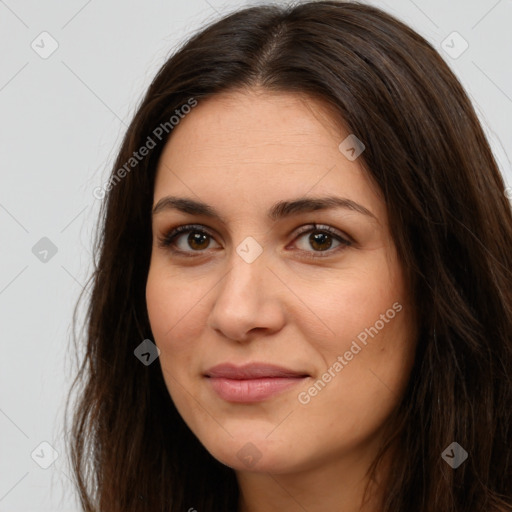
[66,1,512,512]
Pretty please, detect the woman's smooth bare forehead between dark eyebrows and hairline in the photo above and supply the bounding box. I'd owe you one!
[154,89,385,222]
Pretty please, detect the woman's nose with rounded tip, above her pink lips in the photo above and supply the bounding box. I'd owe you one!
[208,246,285,343]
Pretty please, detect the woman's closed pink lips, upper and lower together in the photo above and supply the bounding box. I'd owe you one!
[205,363,309,403]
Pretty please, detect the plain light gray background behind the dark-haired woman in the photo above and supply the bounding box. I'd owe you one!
[0,0,512,512]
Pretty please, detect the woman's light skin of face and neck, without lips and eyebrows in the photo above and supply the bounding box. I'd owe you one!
[146,89,416,512]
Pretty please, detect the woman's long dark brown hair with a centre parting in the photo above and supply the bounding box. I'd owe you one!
[64,1,512,512]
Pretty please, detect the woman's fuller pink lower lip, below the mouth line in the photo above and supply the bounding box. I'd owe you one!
[208,377,306,403]
